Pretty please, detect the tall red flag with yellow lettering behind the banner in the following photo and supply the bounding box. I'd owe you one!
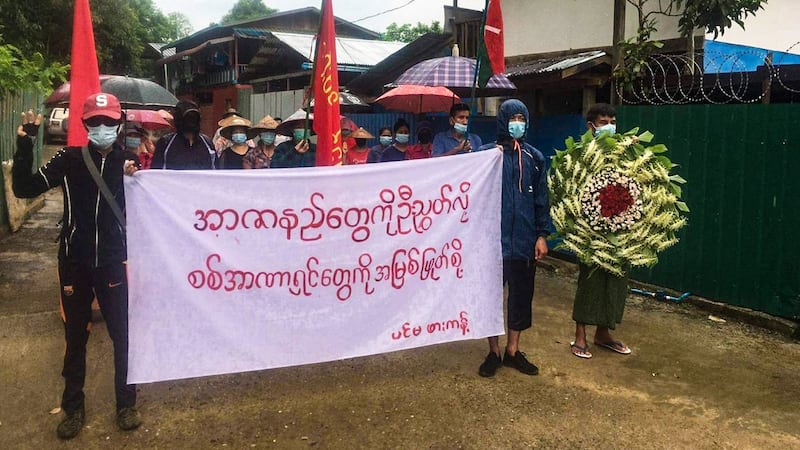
[312,0,342,166]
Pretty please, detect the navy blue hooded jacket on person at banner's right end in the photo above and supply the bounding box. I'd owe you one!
[480,99,550,260]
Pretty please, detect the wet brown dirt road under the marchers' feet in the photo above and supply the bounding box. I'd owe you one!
[0,164,800,449]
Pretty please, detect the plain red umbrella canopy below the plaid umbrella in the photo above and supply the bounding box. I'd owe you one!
[375,84,461,114]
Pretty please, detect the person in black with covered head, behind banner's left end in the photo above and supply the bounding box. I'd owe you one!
[150,100,217,170]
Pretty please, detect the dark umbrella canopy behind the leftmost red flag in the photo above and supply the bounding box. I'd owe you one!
[44,75,178,109]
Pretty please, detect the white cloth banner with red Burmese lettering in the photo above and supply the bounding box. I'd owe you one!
[125,151,504,383]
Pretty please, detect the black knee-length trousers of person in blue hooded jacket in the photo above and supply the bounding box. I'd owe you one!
[503,259,536,331]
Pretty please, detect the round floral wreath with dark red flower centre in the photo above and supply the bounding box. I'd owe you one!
[548,128,689,276]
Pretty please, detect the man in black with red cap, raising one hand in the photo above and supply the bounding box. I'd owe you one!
[12,93,141,439]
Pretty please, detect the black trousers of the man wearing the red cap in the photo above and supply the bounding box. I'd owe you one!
[58,261,136,412]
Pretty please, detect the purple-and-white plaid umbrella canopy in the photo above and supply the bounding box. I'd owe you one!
[392,56,517,95]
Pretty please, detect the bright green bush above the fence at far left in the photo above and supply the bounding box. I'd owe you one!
[0,37,69,98]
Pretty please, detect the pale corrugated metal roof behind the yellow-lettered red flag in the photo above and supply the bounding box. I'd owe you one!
[234,28,406,67]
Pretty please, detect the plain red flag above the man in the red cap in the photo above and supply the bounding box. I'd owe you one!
[67,0,100,147]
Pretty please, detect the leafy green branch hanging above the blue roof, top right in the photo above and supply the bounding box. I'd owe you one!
[674,0,767,39]
